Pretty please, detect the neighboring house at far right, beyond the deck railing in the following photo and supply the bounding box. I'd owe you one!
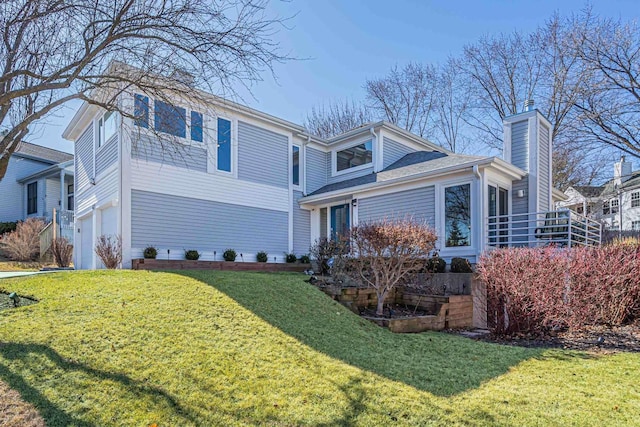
[558,156,640,231]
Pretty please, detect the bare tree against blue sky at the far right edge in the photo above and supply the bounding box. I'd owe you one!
[576,18,640,157]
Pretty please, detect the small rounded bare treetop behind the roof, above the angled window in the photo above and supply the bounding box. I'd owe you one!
[304,100,372,138]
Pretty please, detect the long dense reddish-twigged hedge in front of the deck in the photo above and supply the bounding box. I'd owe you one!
[477,246,640,334]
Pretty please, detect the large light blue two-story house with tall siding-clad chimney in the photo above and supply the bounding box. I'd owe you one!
[63,78,592,268]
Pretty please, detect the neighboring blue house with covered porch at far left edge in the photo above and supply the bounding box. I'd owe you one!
[0,141,74,238]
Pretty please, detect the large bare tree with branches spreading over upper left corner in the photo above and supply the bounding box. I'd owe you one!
[0,0,287,178]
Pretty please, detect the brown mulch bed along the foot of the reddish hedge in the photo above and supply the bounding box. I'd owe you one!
[458,320,640,353]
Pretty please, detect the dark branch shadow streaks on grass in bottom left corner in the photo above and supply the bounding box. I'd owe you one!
[0,342,195,427]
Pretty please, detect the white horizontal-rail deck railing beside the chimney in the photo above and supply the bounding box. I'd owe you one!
[485,209,602,248]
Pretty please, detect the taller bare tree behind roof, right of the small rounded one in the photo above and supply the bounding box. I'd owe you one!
[364,63,437,137]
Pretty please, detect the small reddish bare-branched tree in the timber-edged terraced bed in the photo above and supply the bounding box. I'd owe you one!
[346,218,437,316]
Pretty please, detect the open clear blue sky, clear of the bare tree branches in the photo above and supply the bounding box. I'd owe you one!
[27,0,640,152]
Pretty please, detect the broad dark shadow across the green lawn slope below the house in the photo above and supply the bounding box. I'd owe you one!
[174,271,560,400]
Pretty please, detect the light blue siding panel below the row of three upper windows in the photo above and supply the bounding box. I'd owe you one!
[131,135,207,172]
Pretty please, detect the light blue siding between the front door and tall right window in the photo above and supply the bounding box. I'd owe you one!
[358,185,436,227]
